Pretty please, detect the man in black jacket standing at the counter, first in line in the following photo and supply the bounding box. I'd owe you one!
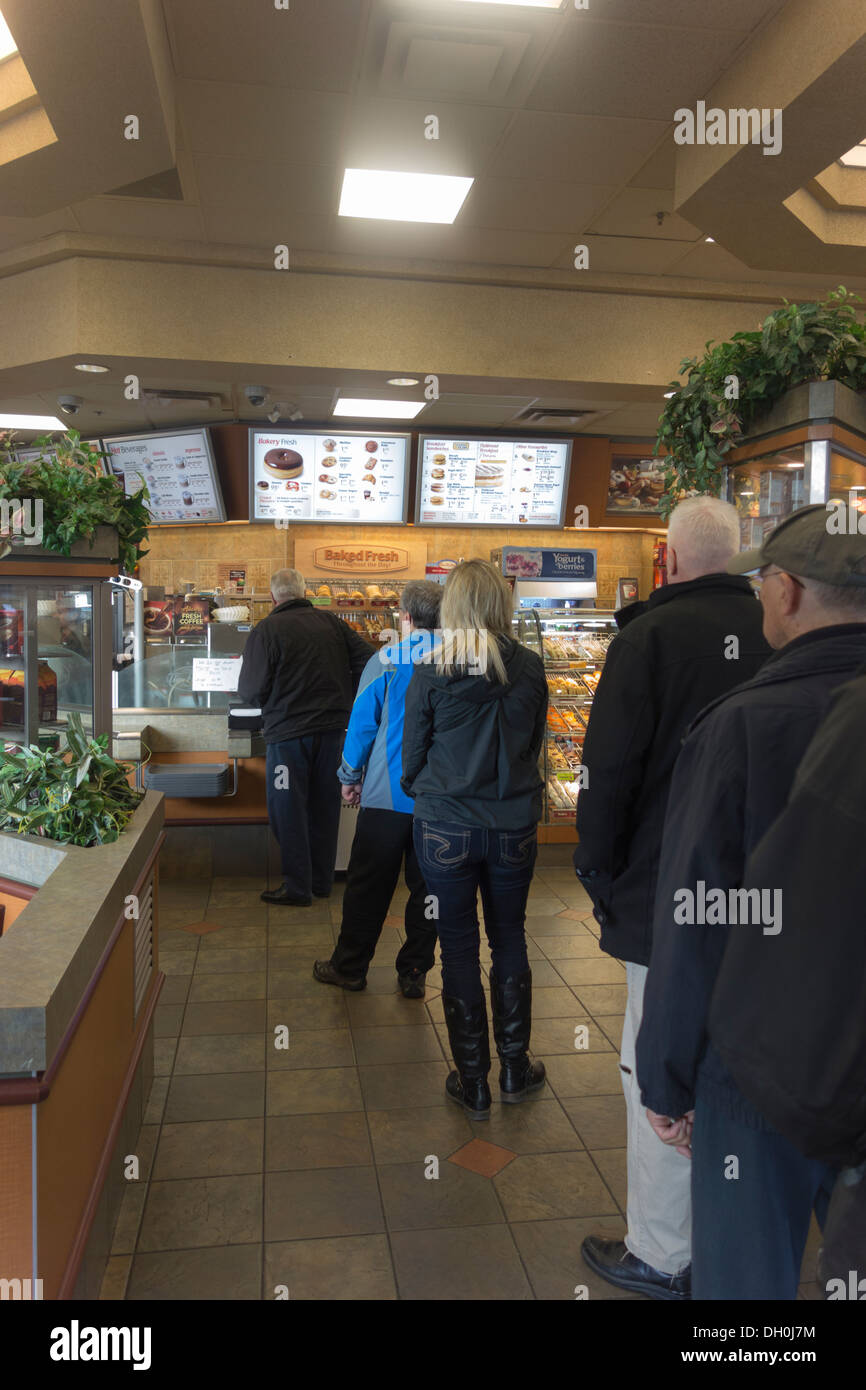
[238,570,373,908]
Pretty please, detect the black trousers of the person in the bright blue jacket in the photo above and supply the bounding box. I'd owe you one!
[331,806,436,976]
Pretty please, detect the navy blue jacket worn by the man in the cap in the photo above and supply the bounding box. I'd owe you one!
[637,623,866,1129]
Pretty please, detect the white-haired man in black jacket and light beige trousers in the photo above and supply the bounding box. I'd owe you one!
[574,498,769,1300]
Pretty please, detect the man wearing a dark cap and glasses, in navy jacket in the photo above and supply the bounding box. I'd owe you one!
[637,505,866,1300]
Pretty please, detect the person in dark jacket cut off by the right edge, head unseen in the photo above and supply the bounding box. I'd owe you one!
[709,674,866,1300]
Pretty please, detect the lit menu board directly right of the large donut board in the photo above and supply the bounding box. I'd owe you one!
[416,435,571,527]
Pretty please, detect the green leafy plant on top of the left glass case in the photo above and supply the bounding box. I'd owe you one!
[0,430,150,573]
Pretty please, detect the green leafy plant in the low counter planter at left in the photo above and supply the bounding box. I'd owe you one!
[0,714,145,847]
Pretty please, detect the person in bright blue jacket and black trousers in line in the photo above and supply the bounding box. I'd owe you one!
[313,580,442,999]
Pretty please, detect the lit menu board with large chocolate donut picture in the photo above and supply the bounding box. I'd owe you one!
[250,430,409,524]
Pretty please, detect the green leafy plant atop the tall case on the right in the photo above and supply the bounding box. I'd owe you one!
[655,285,866,516]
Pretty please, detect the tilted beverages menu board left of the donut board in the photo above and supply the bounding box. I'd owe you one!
[103,430,225,525]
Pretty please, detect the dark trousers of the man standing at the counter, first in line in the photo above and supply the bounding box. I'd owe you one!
[267,730,343,898]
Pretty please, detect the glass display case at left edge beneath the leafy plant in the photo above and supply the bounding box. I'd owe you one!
[0,573,111,748]
